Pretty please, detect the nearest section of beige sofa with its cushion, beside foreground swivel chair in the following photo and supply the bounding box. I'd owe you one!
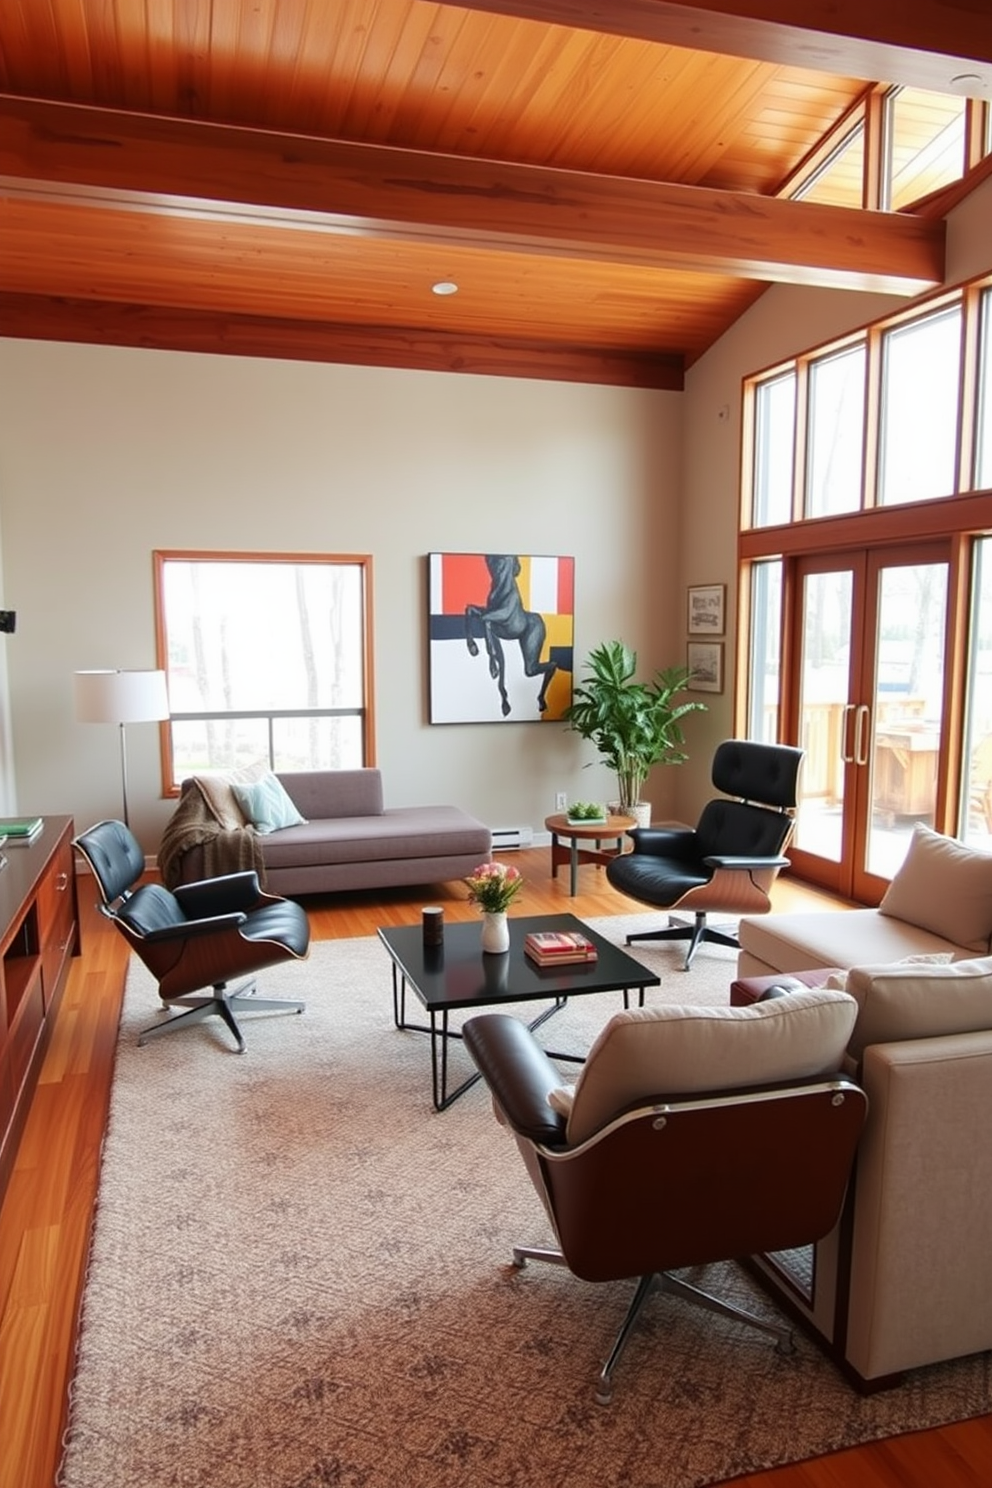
[743,957,992,1390]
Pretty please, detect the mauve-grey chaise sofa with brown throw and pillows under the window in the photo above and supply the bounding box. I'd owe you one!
[159,769,492,894]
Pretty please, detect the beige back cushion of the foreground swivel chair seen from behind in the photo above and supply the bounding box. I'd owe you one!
[552,988,857,1144]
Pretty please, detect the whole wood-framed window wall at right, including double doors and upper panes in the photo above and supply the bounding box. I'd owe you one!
[736,274,992,903]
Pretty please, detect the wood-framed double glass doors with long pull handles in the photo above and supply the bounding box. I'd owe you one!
[790,543,949,903]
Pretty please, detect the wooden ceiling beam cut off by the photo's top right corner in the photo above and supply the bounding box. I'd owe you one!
[449,0,992,98]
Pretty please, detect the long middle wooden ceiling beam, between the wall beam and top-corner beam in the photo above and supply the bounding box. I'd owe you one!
[0,97,944,295]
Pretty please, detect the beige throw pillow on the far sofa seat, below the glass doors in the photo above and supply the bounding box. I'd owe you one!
[879,823,992,951]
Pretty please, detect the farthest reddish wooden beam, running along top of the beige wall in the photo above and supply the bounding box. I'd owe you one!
[0,292,684,393]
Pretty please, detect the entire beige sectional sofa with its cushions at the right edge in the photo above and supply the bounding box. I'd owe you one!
[732,829,992,1388]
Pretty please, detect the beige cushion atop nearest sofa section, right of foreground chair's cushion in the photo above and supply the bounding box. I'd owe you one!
[845,957,992,1059]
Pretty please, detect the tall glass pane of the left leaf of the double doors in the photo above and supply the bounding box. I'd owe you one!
[796,570,854,863]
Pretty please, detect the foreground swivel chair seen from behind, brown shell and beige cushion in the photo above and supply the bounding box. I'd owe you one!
[463,990,867,1405]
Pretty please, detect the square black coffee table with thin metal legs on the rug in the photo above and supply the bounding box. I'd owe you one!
[378,915,660,1112]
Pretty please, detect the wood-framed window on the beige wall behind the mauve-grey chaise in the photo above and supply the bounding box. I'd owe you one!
[155,552,373,792]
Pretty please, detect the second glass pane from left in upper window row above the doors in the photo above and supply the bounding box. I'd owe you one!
[806,345,864,516]
